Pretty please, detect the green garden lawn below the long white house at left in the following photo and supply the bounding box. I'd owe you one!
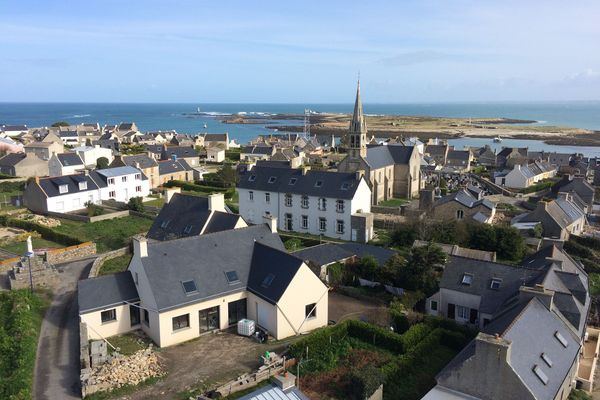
[54,215,152,253]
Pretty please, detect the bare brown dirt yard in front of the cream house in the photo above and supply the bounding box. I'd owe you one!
[120,331,290,400]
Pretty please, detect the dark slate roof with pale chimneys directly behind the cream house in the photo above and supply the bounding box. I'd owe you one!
[147,193,241,240]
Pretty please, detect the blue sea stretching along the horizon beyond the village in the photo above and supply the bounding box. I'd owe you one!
[0,101,600,157]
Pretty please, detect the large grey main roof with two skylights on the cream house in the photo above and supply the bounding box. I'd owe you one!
[141,225,287,311]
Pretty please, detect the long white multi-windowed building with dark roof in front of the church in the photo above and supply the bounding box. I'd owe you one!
[238,166,373,242]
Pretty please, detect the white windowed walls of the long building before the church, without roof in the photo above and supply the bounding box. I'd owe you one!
[238,179,372,240]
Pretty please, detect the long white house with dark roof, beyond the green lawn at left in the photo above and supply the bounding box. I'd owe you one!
[23,167,150,213]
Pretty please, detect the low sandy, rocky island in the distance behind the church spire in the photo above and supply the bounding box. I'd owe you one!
[216,113,600,146]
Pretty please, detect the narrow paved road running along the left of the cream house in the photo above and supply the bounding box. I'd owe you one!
[33,259,93,400]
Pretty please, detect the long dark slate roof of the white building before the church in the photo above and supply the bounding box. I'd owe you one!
[238,166,364,199]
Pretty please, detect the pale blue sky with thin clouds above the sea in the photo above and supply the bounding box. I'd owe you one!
[0,0,600,103]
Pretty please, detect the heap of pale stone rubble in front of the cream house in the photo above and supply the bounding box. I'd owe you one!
[81,346,164,394]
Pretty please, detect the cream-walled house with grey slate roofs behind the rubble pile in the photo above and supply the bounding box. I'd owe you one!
[78,224,329,347]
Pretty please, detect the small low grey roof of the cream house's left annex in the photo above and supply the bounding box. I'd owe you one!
[77,271,139,314]
